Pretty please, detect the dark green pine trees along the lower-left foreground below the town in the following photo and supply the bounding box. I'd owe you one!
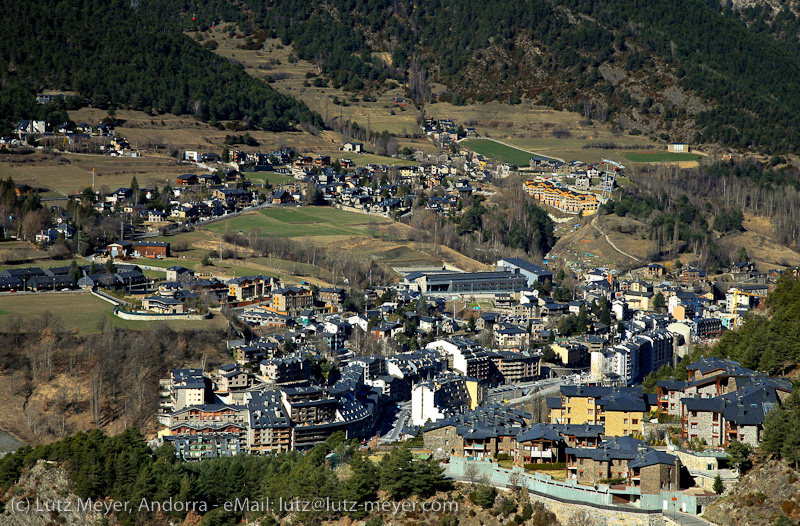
[0,428,454,525]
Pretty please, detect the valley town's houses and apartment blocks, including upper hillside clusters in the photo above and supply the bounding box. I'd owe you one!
[0,112,792,516]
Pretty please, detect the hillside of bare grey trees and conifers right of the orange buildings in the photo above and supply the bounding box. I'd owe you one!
[600,158,800,271]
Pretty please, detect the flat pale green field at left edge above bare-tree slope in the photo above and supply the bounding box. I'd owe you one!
[0,292,225,334]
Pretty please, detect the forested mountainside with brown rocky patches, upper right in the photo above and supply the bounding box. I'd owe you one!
[152,0,800,155]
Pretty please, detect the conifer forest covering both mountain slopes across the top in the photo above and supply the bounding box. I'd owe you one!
[7,0,800,152]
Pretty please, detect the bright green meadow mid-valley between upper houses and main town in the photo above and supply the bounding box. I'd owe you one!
[205,207,389,237]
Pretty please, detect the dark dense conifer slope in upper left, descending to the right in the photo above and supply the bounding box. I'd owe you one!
[0,0,320,137]
